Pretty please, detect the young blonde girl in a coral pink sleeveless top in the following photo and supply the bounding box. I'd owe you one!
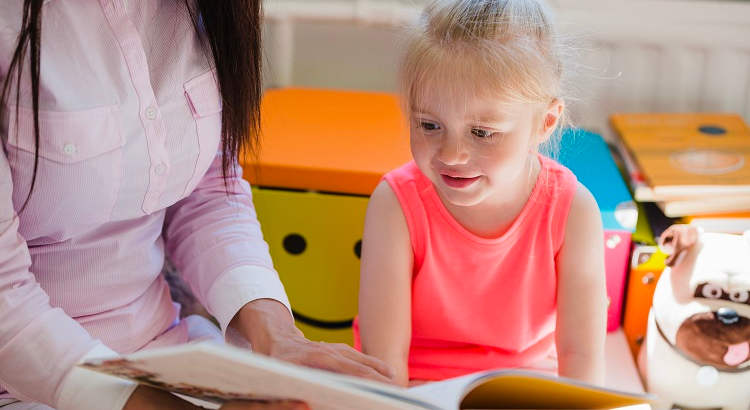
[355,0,607,385]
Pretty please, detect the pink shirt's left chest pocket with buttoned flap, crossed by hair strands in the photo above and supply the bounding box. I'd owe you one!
[7,106,125,240]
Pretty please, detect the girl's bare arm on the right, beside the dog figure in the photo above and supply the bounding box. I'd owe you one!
[556,184,607,385]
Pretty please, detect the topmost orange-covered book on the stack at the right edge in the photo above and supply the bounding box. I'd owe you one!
[611,113,750,202]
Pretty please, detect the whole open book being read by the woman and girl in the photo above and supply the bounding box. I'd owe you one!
[80,342,654,410]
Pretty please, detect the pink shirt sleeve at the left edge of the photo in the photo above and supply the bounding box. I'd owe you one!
[0,148,108,408]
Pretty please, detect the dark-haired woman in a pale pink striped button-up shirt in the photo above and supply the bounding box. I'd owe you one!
[0,0,389,410]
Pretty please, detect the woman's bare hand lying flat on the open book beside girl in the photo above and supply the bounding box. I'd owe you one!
[231,299,393,383]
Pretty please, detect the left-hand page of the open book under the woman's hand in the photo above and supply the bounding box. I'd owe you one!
[82,342,441,410]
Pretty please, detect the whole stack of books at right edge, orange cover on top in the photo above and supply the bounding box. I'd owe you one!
[611,113,750,233]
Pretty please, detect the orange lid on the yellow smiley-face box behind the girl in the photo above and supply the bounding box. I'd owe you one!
[240,89,411,195]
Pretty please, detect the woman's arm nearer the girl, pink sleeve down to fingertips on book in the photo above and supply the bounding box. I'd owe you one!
[164,154,390,382]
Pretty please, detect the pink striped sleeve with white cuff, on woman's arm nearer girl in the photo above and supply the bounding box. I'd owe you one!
[164,153,291,336]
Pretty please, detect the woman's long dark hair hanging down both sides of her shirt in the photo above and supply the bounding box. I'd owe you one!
[0,0,262,213]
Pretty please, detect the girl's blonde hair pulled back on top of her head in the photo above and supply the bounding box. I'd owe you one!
[399,0,563,138]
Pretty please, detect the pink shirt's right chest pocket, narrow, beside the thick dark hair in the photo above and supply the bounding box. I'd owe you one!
[183,69,222,196]
